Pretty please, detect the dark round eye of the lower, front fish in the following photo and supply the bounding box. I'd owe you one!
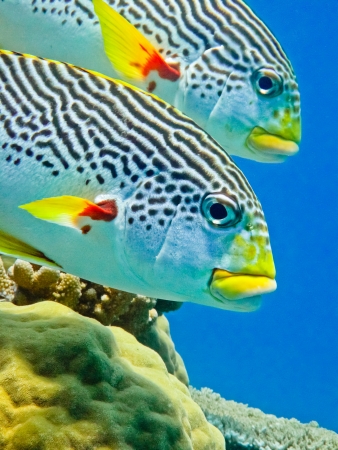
[202,193,241,227]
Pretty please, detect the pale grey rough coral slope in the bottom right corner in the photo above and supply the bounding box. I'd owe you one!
[190,388,338,450]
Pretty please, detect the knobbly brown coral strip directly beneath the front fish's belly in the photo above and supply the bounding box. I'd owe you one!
[7,259,156,328]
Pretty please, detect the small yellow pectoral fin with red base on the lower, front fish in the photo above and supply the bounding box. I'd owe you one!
[19,195,118,229]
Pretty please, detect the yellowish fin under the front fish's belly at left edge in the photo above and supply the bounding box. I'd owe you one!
[0,231,61,269]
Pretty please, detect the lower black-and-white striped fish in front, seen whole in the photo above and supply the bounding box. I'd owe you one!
[0,50,276,311]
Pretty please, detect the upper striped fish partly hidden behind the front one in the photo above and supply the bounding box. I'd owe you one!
[0,0,301,163]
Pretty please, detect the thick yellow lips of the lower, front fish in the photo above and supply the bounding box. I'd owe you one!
[210,269,277,301]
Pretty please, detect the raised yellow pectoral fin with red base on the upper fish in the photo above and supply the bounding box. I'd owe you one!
[93,0,180,81]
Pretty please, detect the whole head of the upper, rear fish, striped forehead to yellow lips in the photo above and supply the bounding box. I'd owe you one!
[185,20,301,162]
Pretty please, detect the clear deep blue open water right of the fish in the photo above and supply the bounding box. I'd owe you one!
[169,0,338,432]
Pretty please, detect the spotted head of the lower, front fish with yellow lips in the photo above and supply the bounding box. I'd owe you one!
[124,157,276,311]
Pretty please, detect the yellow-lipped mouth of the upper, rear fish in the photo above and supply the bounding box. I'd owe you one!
[246,127,299,162]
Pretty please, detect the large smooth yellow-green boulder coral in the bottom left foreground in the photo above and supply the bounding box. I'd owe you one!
[0,302,225,450]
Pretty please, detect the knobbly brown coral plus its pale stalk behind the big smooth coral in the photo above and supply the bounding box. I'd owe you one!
[0,258,189,385]
